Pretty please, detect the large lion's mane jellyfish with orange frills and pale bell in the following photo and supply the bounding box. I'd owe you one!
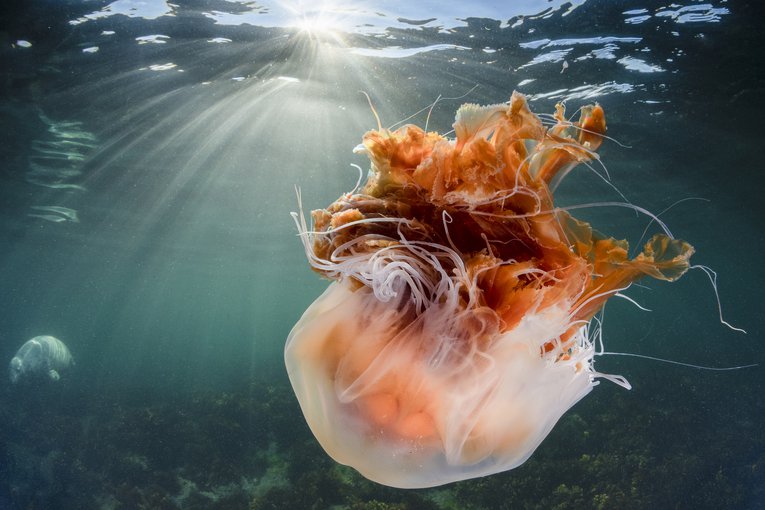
[285,93,693,488]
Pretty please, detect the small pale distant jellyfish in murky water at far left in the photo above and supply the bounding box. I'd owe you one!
[10,335,73,384]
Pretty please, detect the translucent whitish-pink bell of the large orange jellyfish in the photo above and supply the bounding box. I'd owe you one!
[287,283,594,488]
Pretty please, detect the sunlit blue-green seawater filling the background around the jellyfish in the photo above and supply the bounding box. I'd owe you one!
[0,0,765,509]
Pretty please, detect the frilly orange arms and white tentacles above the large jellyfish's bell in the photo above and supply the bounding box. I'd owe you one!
[290,93,693,358]
